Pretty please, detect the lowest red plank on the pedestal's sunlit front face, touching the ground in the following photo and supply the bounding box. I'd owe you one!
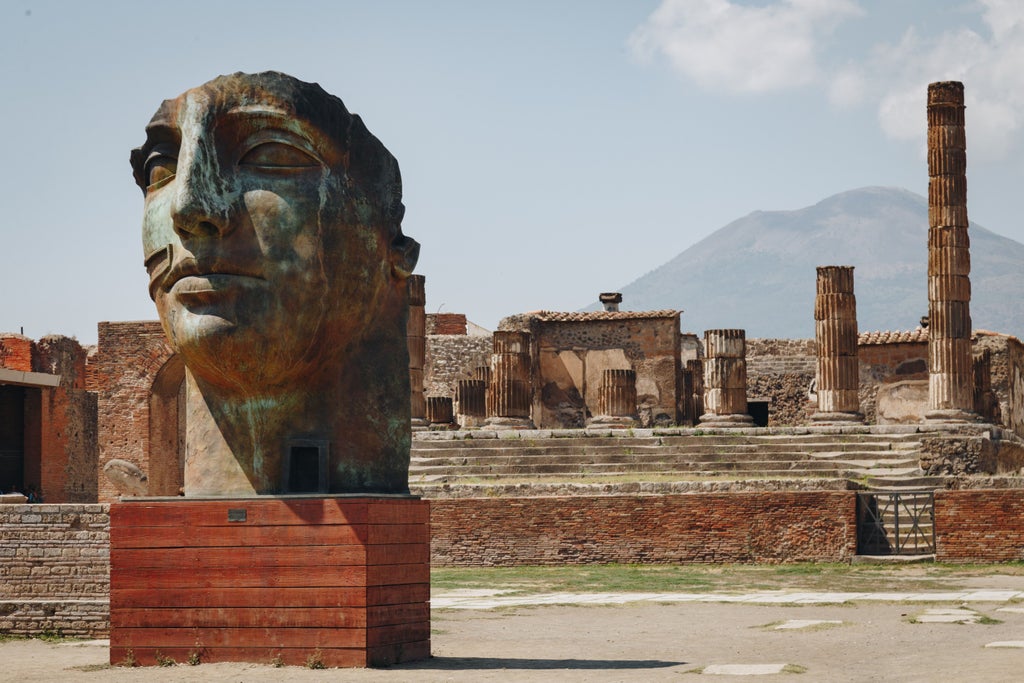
[110,645,370,667]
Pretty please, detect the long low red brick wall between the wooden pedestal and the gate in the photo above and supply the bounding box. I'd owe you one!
[430,492,857,566]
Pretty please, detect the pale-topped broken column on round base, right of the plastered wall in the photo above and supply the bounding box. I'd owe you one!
[700,330,754,427]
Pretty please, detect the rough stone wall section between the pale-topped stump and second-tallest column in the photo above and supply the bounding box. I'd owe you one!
[746,339,818,427]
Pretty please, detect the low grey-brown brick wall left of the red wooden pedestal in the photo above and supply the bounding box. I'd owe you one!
[0,505,110,637]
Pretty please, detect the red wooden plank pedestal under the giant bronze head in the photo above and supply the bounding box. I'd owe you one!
[111,497,430,667]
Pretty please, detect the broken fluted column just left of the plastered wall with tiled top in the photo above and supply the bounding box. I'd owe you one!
[486,331,534,429]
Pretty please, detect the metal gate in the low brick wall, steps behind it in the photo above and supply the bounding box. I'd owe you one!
[857,490,935,555]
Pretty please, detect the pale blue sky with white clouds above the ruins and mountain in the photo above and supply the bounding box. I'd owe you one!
[0,0,1024,343]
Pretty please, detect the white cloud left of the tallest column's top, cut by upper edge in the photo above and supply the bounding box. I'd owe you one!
[629,0,859,93]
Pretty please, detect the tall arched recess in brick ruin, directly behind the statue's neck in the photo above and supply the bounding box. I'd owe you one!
[145,354,185,496]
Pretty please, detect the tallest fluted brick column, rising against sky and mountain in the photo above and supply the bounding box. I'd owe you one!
[925,81,977,422]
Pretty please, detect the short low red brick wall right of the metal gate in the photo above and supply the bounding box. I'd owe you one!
[935,488,1024,562]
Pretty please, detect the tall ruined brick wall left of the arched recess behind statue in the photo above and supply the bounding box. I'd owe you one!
[89,321,172,502]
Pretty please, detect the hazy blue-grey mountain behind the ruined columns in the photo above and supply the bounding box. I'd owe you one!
[588,187,1024,338]
